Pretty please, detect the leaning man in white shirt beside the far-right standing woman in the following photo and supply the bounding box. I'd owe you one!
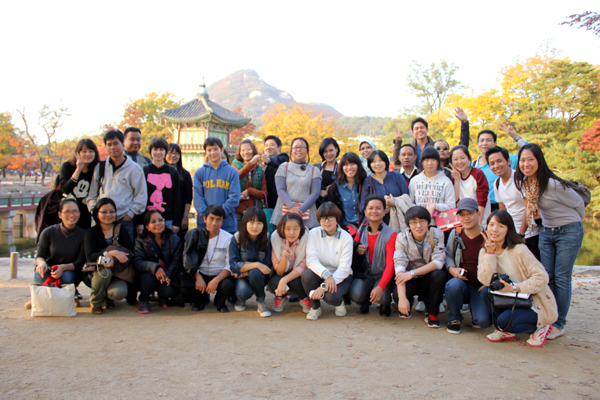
[485,146,540,260]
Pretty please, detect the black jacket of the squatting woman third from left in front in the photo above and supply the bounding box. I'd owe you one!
[133,229,182,279]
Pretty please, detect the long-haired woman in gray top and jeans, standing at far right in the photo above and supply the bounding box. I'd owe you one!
[515,143,585,339]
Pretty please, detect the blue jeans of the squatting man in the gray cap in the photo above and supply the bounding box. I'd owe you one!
[446,278,492,328]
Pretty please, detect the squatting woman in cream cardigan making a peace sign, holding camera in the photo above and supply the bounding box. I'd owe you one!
[477,210,558,347]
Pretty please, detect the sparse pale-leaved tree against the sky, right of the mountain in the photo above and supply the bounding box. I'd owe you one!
[407,60,462,115]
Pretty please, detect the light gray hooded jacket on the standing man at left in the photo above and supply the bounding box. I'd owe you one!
[86,156,148,220]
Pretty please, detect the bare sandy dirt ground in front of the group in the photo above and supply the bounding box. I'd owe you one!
[0,259,600,399]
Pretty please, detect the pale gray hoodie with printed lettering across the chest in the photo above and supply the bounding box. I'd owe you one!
[408,171,456,212]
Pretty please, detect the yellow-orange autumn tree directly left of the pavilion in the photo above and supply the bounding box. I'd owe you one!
[115,92,182,155]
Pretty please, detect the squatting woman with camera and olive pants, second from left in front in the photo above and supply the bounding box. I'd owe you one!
[83,197,133,314]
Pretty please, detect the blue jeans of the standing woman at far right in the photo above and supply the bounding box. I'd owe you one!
[539,222,583,329]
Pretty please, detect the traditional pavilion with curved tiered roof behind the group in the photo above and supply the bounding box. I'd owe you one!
[160,83,251,173]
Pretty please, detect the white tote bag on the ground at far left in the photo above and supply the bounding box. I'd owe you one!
[29,284,77,317]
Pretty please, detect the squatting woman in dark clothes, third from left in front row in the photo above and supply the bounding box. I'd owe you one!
[133,210,183,314]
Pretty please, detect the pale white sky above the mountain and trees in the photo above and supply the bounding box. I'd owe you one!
[0,1,600,136]
